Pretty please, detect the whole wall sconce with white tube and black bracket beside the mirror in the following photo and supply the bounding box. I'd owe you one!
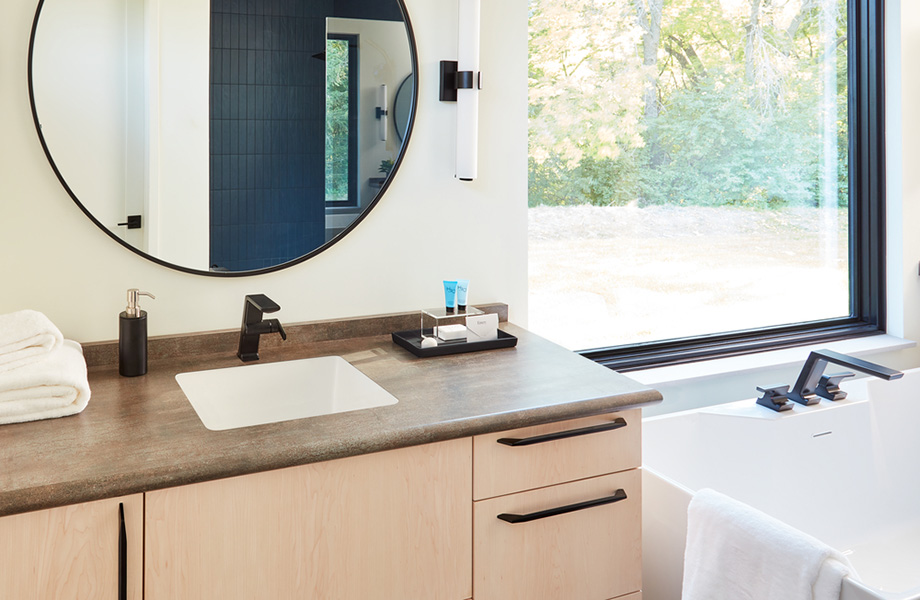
[440,0,482,181]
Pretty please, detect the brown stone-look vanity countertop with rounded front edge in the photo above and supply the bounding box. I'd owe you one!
[0,323,661,516]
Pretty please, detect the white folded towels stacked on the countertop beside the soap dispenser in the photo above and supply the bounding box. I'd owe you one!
[0,311,90,424]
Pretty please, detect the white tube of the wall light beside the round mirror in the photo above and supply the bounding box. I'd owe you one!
[457,0,480,181]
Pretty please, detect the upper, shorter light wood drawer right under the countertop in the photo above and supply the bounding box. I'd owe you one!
[473,408,641,500]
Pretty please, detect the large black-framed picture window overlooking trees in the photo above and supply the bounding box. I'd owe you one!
[529,0,884,369]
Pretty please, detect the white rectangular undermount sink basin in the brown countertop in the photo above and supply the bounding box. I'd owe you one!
[176,356,397,431]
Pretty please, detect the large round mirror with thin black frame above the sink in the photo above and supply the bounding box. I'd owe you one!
[29,0,417,276]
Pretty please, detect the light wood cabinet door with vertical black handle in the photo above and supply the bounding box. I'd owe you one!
[0,494,144,600]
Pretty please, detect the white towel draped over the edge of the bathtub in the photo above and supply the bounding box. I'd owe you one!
[681,489,855,600]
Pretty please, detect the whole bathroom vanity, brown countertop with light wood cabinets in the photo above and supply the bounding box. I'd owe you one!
[0,312,660,600]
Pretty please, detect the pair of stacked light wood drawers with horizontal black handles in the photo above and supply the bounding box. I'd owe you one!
[473,409,642,600]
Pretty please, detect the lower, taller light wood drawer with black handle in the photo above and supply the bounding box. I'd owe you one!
[473,469,642,600]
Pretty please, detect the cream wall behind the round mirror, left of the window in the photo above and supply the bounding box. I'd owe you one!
[0,0,527,342]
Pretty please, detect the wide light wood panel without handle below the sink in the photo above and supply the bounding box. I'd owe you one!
[145,438,472,600]
